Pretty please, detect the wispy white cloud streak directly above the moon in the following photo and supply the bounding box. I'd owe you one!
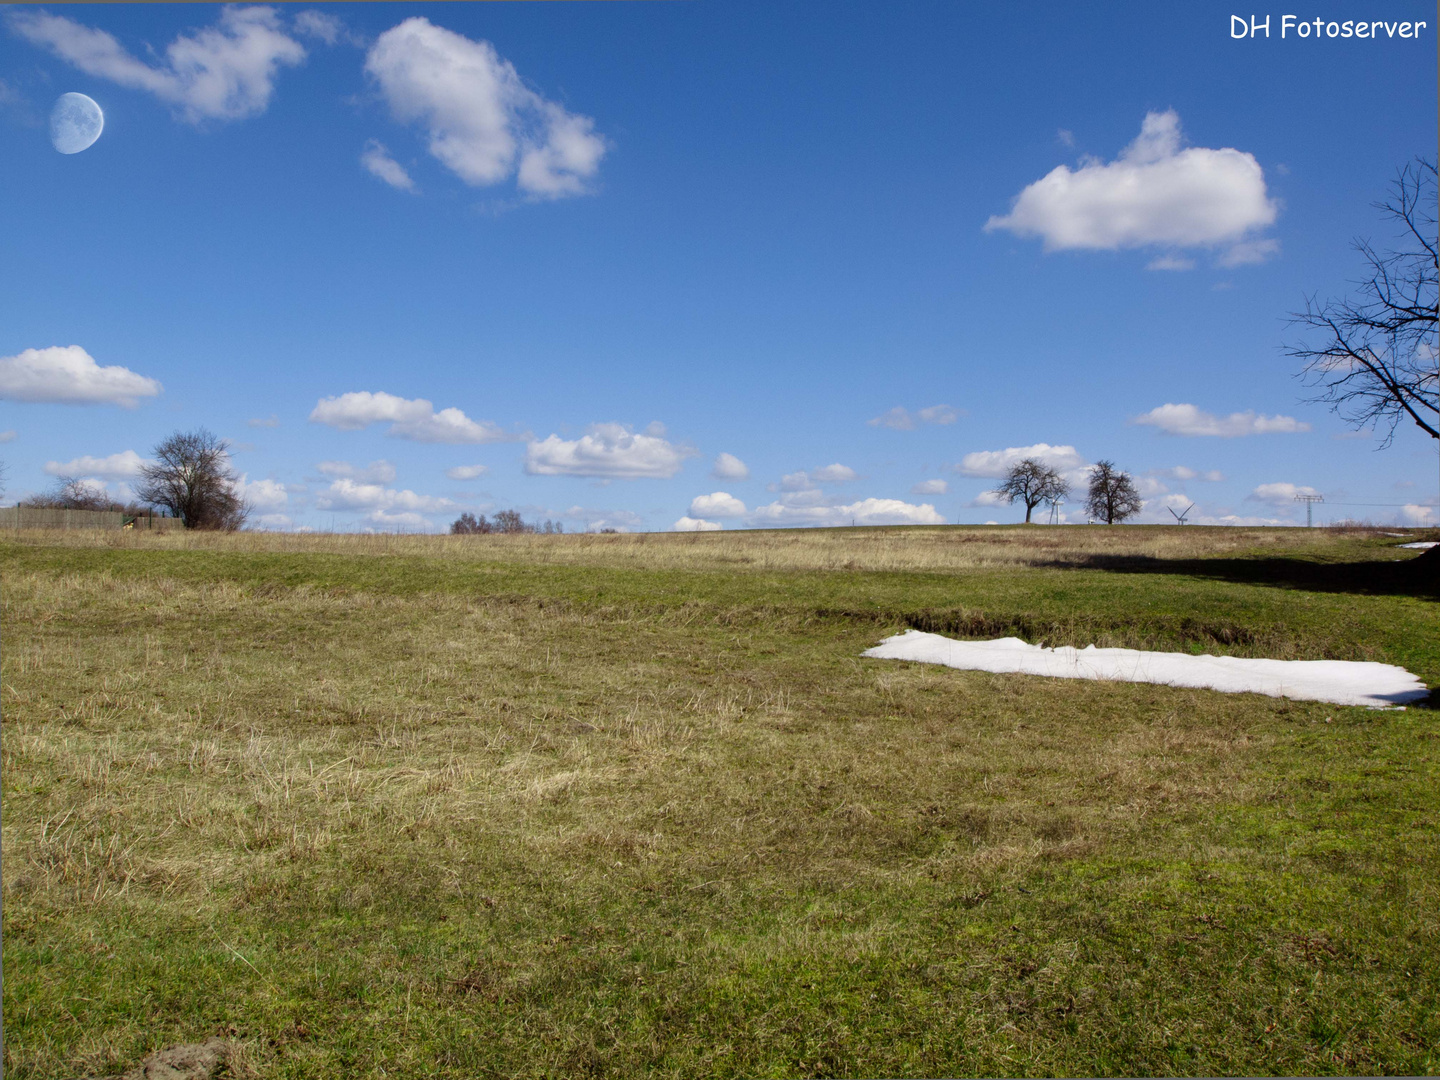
[9,7,305,124]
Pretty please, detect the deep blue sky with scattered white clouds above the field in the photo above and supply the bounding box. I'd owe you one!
[0,0,1437,531]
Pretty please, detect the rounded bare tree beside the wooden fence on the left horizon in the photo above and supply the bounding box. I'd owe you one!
[135,428,249,531]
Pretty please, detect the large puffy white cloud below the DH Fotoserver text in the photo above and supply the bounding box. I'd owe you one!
[985,109,1277,264]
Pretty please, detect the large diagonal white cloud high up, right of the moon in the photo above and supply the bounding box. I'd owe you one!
[366,17,606,199]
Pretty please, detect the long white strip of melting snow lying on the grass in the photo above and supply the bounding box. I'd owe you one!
[861,631,1430,708]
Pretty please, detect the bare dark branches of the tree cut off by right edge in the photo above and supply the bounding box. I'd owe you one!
[1286,158,1440,446]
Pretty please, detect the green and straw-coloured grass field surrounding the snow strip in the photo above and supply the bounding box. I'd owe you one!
[0,527,1440,1080]
